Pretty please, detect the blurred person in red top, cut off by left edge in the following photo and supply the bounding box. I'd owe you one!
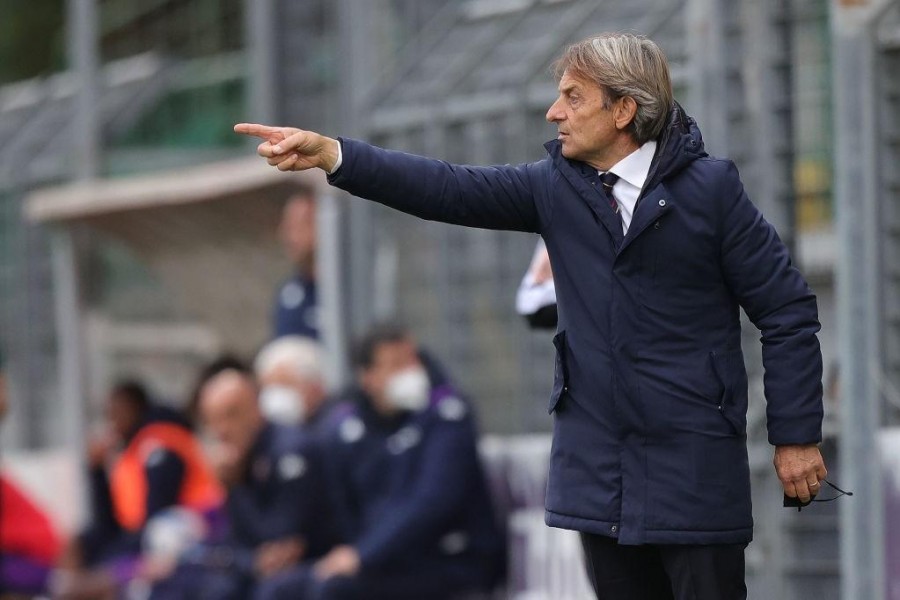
[0,354,62,597]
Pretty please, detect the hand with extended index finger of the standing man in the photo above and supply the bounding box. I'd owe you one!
[234,123,338,172]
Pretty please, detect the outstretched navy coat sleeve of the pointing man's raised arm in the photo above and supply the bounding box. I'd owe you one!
[328,138,547,233]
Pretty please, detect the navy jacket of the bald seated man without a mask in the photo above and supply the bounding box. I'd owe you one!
[226,424,334,557]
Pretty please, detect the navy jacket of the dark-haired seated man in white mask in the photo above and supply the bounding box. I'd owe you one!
[325,386,503,584]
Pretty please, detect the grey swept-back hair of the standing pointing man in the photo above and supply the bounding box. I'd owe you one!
[553,33,674,144]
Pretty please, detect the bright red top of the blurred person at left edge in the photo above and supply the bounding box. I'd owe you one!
[0,475,62,566]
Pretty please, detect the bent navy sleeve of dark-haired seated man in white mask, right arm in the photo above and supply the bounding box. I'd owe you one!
[354,418,481,569]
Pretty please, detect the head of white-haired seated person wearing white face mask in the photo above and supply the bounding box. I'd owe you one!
[253,335,337,431]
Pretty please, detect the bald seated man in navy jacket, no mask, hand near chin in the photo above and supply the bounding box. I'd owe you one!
[153,369,333,600]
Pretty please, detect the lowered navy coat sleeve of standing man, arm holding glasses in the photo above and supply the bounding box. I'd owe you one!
[719,161,823,445]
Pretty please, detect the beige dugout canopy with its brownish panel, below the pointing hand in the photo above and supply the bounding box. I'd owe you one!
[25,156,324,352]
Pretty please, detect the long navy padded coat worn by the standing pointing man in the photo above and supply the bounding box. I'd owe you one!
[330,105,822,544]
